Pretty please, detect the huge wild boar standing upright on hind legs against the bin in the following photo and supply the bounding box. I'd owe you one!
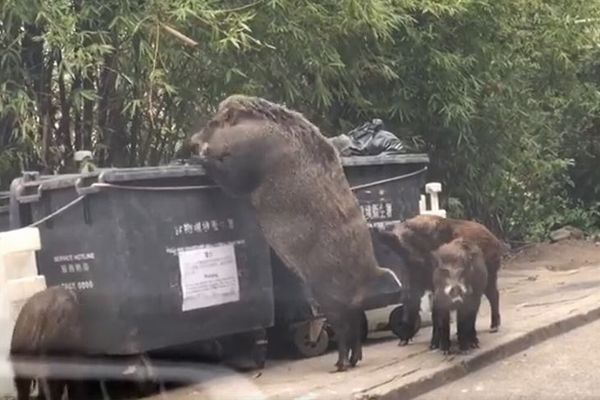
[192,95,401,371]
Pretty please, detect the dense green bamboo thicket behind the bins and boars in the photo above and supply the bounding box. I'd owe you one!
[0,0,600,240]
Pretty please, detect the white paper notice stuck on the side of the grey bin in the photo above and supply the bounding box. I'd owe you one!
[179,244,240,311]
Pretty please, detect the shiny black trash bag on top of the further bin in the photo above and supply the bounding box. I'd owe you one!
[329,118,406,156]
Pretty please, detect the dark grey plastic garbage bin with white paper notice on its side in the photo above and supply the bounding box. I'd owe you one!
[11,166,273,355]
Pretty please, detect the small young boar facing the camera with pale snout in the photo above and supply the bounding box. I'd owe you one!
[430,238,487,354]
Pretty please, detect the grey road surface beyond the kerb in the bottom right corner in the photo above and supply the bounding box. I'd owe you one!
[417,321,600,400]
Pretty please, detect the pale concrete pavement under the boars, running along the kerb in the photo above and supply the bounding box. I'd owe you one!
[141,266,600,400]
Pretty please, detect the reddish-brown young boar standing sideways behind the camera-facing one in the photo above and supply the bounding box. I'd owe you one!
[377,215,505,344]
